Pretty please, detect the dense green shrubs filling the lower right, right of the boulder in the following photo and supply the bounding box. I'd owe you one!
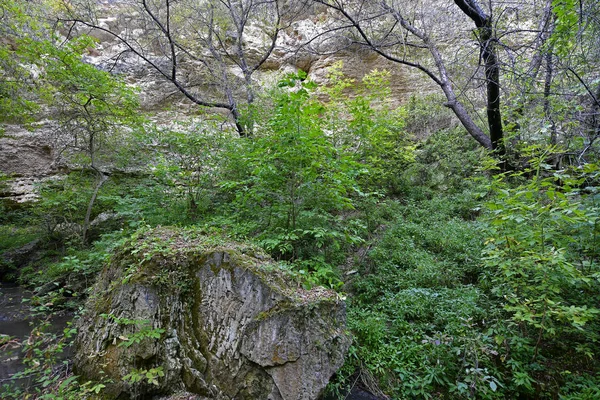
[335,131,600,399]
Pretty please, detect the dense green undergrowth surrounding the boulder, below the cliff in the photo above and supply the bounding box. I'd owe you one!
[0,70,600,399]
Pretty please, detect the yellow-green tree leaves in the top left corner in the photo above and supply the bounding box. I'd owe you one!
[0,0,137,132]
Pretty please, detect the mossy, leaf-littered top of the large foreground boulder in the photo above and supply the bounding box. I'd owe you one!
[100,227,337,303]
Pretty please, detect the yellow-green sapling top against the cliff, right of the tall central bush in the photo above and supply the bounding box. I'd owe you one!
[321,63,416,193]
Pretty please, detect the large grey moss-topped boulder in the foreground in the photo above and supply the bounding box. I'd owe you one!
[75,228,350,400]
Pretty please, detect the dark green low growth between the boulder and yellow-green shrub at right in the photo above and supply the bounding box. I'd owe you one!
[334,130,492,399]
